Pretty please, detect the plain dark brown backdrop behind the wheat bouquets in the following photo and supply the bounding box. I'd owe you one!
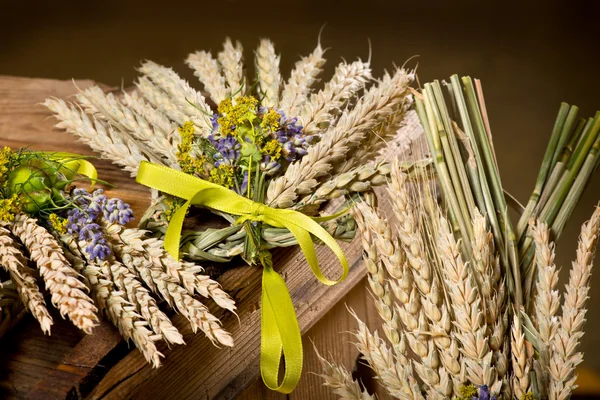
[0,0,600,384]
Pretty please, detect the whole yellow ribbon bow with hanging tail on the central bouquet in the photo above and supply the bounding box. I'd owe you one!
[136,162,348,394]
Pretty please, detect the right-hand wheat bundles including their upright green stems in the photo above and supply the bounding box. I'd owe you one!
[322,76,600,400]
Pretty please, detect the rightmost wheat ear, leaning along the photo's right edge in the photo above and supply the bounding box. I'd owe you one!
[548,207,600,400]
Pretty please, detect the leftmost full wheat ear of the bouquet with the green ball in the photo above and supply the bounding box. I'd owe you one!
[0,227,53,334]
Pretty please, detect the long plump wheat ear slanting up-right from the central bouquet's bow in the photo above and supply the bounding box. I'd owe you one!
[266,69,408,208]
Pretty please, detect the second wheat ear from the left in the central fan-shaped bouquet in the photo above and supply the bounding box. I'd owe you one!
[77,86,178,168]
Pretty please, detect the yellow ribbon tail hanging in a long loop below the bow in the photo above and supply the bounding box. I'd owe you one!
[260,266,303,394]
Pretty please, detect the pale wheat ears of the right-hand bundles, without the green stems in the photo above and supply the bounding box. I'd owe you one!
[321,157,600,400]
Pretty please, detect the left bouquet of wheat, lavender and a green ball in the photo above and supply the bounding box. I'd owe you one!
[0,147,235,367]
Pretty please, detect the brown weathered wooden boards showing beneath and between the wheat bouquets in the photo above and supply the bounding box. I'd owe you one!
[0,77,384,399]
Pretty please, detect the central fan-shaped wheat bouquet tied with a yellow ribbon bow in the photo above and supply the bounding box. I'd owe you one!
[45,40,418,393]
